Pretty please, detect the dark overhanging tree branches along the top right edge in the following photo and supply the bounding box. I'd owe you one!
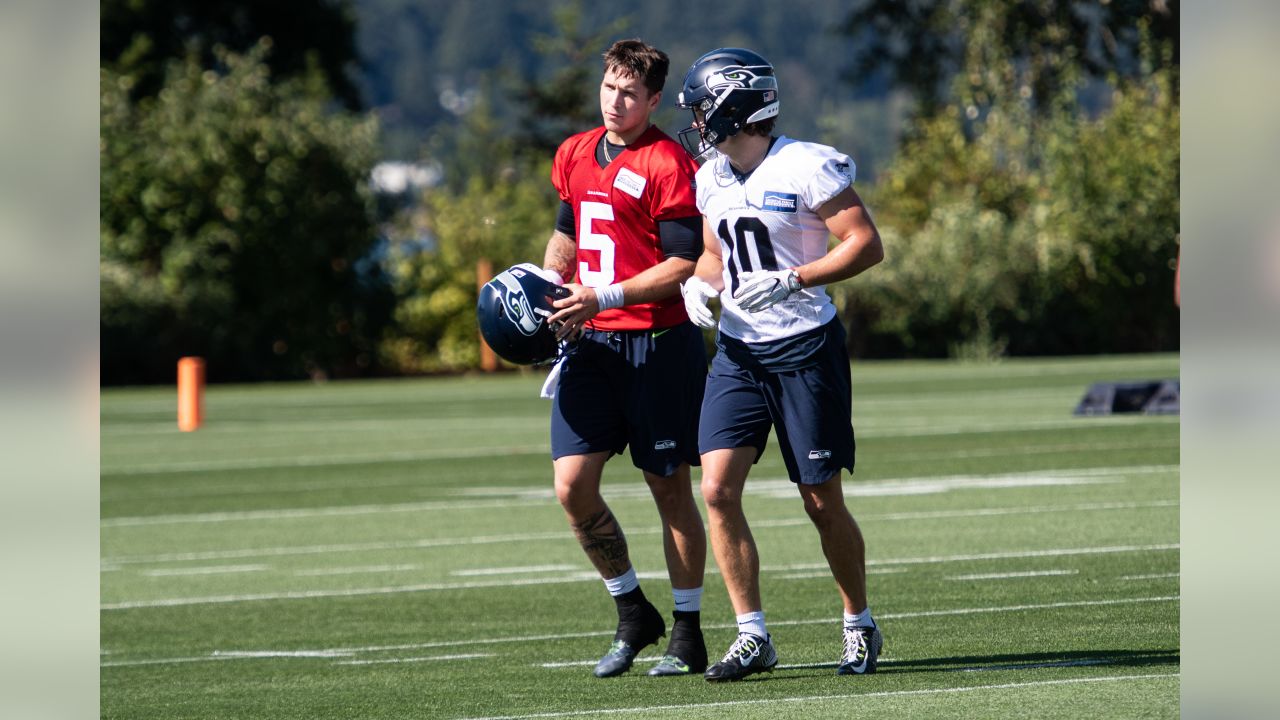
[840,0,1179,115]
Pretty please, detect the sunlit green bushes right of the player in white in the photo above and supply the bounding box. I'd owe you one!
[837,15,1179,357]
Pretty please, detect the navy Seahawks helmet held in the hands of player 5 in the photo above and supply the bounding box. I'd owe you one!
[476,263,570,365]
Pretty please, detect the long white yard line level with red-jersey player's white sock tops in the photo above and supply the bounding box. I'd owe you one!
[100,543,1179,610]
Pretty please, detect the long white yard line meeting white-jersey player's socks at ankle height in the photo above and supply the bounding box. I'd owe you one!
[101,594,1180,667]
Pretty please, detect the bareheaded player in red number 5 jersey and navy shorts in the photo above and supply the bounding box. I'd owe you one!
[532,40,707,678]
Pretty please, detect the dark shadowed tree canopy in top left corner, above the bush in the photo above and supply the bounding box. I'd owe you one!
[100,0,360,109]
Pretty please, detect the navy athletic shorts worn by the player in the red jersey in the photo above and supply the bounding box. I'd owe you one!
[552,322,707,477]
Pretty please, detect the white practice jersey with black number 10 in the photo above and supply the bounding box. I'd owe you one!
[696,137,856,342]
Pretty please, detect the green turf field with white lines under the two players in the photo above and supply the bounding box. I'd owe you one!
[101,355,1179,720]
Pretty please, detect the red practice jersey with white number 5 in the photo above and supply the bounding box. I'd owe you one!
[552,126,698,331]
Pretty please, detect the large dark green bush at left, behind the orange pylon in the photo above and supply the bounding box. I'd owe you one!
[100,41,387,383]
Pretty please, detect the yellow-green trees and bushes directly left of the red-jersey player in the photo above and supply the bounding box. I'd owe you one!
[380,1,625,373]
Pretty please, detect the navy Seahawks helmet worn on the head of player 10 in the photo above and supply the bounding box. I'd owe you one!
[677,47,778,159]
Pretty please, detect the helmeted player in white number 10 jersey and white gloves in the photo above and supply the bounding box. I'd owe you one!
[680,47,884,682]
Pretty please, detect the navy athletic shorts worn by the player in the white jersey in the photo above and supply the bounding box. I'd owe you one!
[698,319,854,484]
